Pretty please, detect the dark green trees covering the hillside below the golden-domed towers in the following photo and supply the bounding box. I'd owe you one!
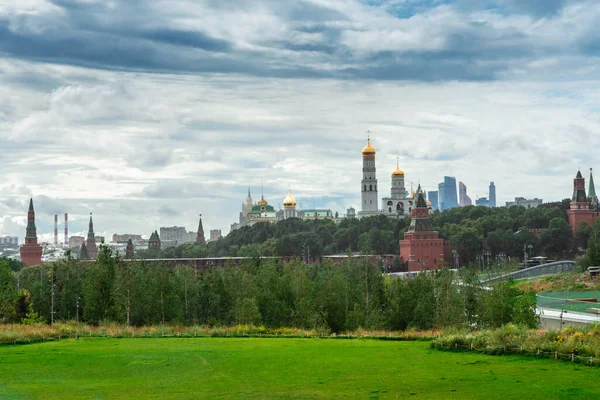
[136,199,576,265]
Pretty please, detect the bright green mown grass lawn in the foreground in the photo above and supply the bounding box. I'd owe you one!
[0,338,600,399]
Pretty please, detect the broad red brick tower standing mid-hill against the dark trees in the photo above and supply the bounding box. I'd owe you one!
[400,185,444,272]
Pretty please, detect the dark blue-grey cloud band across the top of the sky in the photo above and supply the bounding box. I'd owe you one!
[0,0,597,85]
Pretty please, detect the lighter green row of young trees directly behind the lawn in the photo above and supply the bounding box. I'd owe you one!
[0,246,536,332]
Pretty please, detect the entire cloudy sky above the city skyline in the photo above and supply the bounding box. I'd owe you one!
[0,0,600,238]
